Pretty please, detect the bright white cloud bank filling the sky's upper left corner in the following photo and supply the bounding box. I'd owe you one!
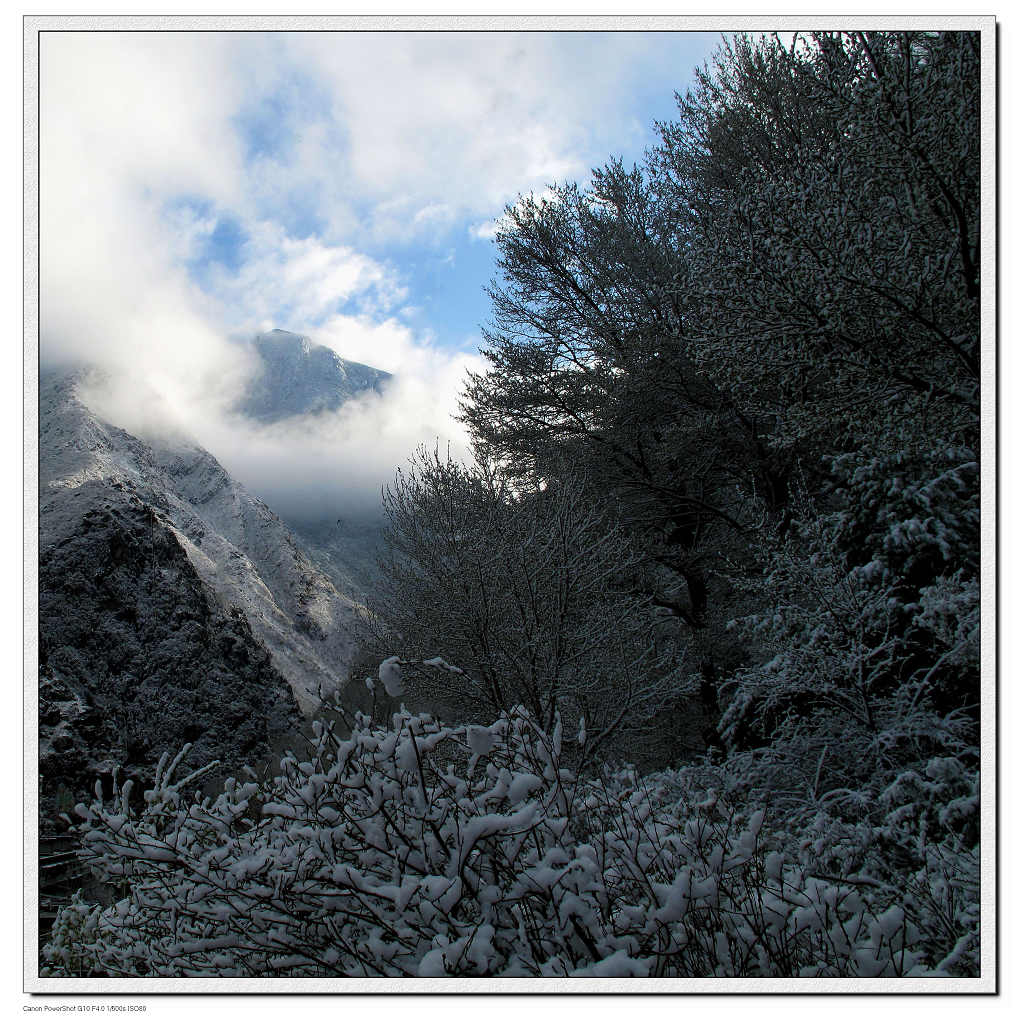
[40,33,257,408]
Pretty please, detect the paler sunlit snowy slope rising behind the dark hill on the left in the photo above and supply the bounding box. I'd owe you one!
[40,376,370,712]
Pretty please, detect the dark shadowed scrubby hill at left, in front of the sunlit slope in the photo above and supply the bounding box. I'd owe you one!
[39,482,297,809]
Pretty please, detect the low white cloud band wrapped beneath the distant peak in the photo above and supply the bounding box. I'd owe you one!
[81,315,482,521]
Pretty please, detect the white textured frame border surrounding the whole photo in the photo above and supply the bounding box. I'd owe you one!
[24,14,999,995]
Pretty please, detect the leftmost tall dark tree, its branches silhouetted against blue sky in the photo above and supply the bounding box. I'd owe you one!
[463,162,790,628]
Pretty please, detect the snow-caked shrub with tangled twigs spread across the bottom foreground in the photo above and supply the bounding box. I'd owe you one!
[45,679,969,977]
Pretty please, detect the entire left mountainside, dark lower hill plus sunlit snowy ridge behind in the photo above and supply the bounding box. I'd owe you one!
[39,372,376,803]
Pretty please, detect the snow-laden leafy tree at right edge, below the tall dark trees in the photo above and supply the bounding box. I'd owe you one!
[720,449,980,816]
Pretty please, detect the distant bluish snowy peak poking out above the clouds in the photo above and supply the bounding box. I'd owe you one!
[238,329,390,423]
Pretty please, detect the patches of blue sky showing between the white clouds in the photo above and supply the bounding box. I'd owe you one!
[202,34,717,347]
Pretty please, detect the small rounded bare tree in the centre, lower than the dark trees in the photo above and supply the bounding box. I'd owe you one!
[370,449,676,754]
